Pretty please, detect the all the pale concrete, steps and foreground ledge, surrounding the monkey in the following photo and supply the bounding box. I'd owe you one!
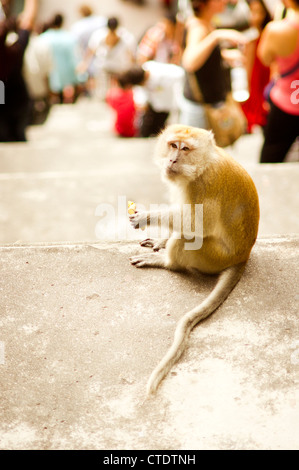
[0,83,299,450]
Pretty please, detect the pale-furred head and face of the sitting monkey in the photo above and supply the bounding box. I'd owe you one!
[156,125,214,182]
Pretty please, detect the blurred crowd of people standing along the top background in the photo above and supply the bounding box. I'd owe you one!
[0,0,299,163]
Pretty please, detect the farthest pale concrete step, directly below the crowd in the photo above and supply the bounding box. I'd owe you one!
[0,98,299,172]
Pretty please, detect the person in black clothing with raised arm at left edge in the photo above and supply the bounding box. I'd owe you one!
[0,0,38,142]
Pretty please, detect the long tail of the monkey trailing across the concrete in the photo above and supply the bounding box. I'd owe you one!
[147,263,246,396]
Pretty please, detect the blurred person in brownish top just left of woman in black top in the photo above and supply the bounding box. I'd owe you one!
[136,13,182,65]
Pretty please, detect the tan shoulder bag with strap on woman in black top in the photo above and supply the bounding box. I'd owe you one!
[188,74,247,147]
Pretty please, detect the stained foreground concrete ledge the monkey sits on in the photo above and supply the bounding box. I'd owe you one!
[0,236,299,450]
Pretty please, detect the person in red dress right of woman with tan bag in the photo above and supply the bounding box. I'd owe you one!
[242,0,271,133]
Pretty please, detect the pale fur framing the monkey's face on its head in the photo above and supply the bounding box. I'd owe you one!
[154,124,216,182]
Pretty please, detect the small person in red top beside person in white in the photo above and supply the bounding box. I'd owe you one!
[106,72,137,137]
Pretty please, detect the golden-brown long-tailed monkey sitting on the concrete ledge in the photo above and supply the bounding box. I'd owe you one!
[130,124,260,397]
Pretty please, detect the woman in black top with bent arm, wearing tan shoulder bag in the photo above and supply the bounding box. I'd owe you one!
[180,0,246,128]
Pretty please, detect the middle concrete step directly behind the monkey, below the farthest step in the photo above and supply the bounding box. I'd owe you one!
[0,152,299,243]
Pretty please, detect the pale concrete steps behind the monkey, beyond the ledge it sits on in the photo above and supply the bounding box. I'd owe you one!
[0,100,299,244]
